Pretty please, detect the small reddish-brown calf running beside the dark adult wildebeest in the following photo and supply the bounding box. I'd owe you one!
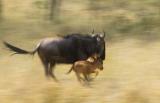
[67,54,103,82]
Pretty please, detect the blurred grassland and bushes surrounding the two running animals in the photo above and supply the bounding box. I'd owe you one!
[0,0,160,103]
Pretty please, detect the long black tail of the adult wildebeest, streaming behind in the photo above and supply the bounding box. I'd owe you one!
[3,41,39,55]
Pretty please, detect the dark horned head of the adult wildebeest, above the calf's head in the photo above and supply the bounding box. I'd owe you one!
[92,30,105,60]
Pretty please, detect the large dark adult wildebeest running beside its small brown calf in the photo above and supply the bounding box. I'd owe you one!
[4,33,105,80]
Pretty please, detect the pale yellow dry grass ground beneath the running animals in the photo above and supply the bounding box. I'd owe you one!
[0,39,160,103]
